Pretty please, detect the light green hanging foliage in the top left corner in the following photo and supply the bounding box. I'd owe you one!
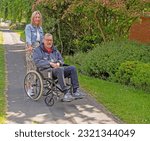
[0,0,34,23]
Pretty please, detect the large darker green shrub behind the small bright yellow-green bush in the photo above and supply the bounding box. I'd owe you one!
[73,39,150,80]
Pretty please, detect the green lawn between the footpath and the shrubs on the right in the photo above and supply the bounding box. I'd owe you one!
[79,75,150,124]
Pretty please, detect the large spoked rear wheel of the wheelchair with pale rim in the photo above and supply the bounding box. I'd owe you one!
[24,70,43,101]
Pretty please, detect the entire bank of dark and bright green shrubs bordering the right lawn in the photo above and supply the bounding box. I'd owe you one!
[70,39,150,92]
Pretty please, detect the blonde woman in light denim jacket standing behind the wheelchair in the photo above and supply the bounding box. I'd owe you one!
[25,11,43,72]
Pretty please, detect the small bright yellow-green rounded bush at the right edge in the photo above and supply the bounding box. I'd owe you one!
[116,61,150,92]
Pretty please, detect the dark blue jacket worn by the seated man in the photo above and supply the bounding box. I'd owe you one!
[33,44,64,68]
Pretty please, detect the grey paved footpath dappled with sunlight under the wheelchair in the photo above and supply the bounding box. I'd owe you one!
[3,29,120,124]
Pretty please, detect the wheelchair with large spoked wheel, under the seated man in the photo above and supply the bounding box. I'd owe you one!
[24,68,72,106]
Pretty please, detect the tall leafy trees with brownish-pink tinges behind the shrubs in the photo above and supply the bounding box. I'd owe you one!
[36,0,146,54]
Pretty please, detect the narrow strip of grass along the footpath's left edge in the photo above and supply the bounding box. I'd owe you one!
[0,32,6,124]
